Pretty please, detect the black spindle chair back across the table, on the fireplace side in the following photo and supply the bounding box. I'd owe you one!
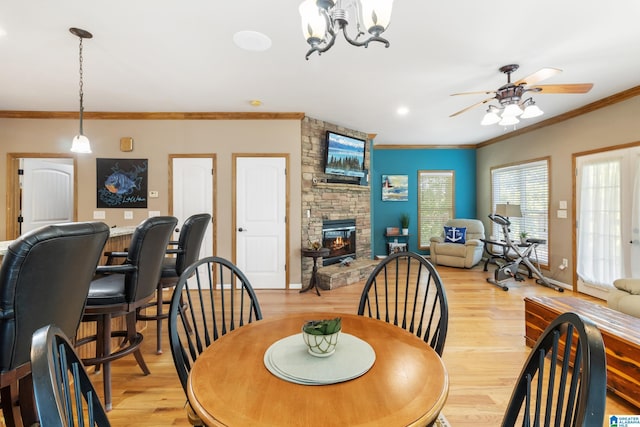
[358,252,449,355]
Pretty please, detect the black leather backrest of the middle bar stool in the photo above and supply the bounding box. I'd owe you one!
[125,216,178,303]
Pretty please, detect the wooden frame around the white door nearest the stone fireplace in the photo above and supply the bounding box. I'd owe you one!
[231,153,291,289]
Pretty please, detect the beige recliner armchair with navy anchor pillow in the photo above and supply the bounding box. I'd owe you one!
[430,218,484,268]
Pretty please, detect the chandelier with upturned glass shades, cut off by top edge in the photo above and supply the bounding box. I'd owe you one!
[299,0,393,60]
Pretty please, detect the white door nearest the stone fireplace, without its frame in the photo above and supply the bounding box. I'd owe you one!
[235,157,286,289]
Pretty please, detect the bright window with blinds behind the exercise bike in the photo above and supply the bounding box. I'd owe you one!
[491,158,549,266]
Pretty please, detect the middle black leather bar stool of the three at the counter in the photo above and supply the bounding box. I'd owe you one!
[76,216,178,411]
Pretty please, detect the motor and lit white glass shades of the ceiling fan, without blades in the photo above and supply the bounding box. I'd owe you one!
[480,65,544,126]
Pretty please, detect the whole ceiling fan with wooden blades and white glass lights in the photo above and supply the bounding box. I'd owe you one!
[449,64,593,125]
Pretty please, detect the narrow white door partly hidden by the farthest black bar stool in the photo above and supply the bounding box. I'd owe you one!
[171,157,215,258]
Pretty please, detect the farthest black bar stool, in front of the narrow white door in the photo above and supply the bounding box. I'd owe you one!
[138,213,211,354]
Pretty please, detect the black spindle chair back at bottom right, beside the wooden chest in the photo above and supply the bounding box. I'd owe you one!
[502,313,607,427]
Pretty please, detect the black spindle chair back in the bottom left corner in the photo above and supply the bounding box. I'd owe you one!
[31,325,110,427]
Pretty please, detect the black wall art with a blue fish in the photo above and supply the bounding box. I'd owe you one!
[96,159,149,208]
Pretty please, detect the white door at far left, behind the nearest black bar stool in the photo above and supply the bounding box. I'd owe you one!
[21,158,74,234]
